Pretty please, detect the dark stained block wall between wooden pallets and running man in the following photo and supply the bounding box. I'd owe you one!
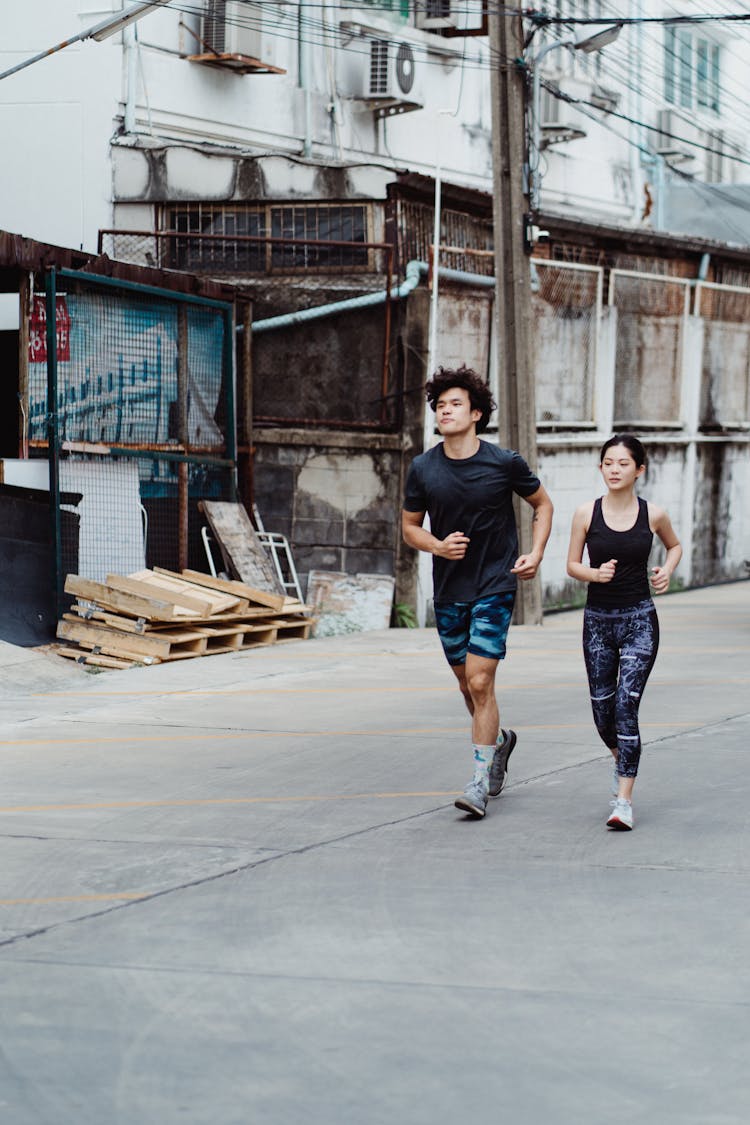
[253,290,430,604]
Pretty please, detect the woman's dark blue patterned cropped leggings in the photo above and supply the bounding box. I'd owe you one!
[584,597,659,777]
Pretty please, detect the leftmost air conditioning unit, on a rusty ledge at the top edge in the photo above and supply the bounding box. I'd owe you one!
[191,0,283,73]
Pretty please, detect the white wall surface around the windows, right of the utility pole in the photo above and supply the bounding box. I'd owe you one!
[528,0,750,228]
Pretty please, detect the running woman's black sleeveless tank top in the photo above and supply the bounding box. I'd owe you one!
[586,496,653,609]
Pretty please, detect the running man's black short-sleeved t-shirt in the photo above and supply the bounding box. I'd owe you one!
[404,441,540,603]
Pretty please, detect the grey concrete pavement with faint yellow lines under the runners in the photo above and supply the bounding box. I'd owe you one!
[0,583,750,1125]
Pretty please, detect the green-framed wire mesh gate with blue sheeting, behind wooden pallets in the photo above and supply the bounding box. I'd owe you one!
[33,269,236,613]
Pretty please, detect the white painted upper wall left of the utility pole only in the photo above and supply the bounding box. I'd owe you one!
[0,0,491,250]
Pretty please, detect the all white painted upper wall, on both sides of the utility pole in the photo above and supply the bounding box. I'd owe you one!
[5,0,750,250]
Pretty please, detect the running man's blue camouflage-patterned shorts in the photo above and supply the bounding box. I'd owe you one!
[435,591,516,665]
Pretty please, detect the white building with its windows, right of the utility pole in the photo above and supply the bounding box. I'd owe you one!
[537,0,750,234]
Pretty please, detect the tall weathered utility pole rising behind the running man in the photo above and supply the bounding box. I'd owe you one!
[488,5,542,624]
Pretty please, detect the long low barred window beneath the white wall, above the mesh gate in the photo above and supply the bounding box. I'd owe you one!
[162,203,372,275]
